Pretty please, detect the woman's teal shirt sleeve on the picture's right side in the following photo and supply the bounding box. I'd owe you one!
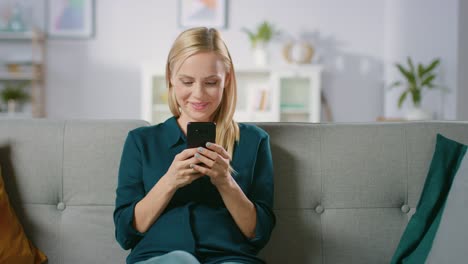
[249,135,276,250]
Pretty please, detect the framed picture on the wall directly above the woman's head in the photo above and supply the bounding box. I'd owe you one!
[179,0,227,28]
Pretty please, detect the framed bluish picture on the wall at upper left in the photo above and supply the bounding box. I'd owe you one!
[47,0,94,38]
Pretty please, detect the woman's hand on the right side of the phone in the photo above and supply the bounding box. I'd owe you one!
[192,143,231,187]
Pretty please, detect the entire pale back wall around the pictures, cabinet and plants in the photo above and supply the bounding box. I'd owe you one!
[0,0,462,122]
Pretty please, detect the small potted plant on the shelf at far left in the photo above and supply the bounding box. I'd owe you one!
[0,81,29,113]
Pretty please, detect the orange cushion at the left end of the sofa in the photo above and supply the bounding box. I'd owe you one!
[0,168,47,264]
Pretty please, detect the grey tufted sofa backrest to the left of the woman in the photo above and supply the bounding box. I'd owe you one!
[0,119,147,264]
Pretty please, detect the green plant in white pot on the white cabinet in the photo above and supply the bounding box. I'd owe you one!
[242,21,279,67]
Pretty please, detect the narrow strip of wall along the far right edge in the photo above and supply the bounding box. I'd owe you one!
[457,0,468,120]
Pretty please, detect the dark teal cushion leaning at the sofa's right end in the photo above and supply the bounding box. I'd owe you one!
[391,134,467,263]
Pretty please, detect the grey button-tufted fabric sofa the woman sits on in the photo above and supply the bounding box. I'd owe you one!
[0,119,468,263]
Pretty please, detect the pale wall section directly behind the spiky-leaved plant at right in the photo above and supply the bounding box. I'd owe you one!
[384,0,459,119]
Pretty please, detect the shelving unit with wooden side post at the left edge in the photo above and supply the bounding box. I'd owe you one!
[0,30,46,118]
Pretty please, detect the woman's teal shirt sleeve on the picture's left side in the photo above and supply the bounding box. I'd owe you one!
[114,132,145,250]
